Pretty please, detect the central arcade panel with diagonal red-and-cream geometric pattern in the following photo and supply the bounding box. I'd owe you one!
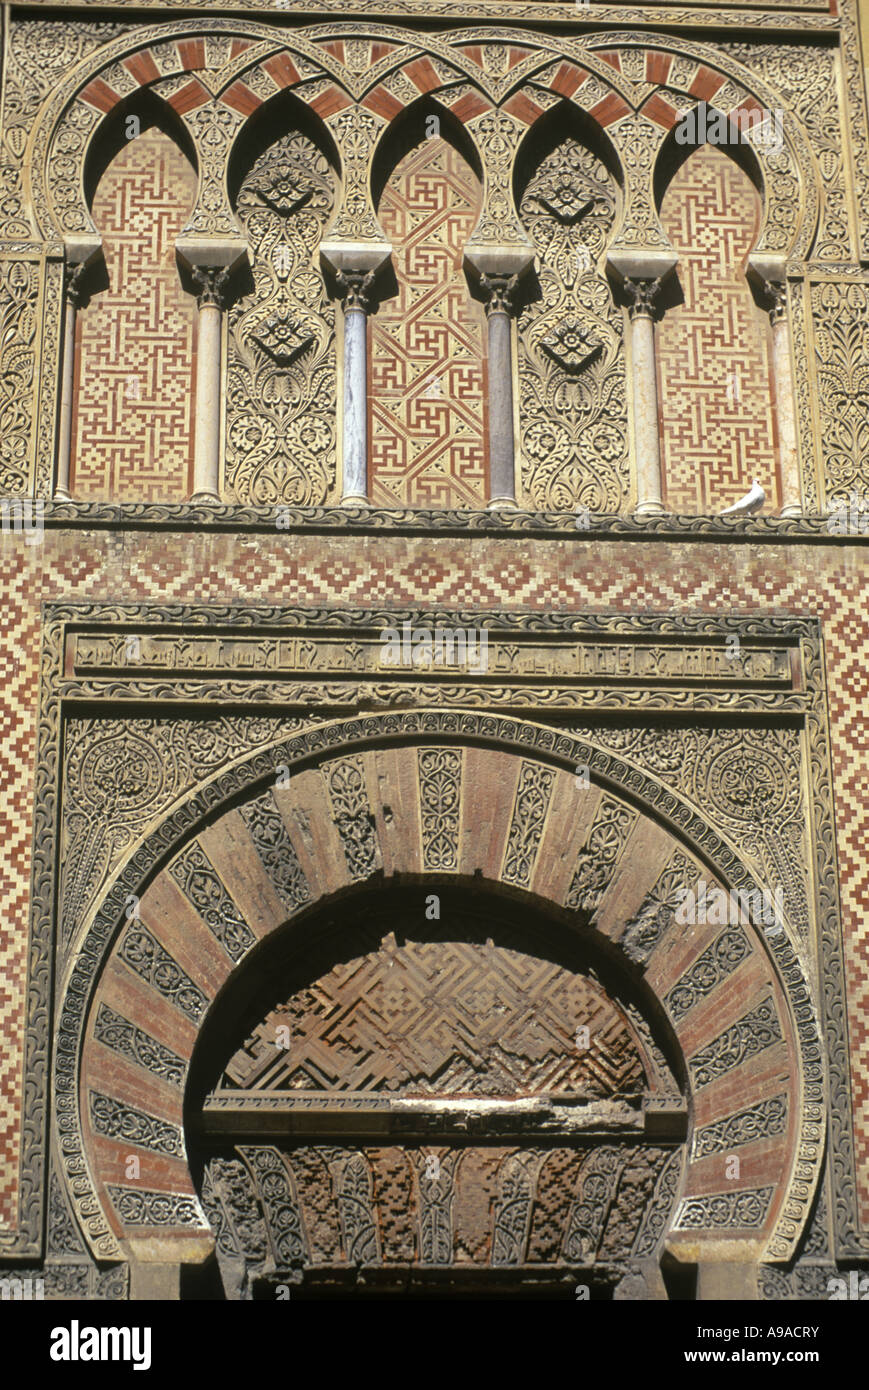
[368,96,491,507]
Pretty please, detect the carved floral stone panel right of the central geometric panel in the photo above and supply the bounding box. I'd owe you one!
[519,138,630,512]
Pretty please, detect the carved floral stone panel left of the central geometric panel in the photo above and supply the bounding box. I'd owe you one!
[227,133,336,506]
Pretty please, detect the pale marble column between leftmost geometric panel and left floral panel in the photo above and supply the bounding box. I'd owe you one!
[190,265,229,502]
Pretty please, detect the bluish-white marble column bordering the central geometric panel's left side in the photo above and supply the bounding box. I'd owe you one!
[338,270,374,506]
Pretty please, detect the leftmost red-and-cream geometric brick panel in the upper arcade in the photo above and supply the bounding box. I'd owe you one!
[72,128,196,502]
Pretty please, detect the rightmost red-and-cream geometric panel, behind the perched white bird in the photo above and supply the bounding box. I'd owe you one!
[655,126,778,512]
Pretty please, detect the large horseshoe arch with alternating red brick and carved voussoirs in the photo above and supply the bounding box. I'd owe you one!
[54,712,823,1278]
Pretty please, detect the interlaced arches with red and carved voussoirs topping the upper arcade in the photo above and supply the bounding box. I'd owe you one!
[28,19,819,256]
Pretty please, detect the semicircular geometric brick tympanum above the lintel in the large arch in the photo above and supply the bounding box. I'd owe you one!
[221,929,644,1099]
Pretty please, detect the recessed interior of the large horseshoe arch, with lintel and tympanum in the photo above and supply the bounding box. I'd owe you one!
[185,883,687,1298]
